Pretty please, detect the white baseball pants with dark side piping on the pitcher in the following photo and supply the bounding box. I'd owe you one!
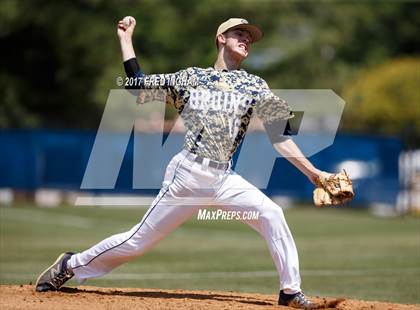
[69,150,301,294]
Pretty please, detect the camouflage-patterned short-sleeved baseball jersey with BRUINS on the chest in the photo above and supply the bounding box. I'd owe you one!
[126,60,293,162]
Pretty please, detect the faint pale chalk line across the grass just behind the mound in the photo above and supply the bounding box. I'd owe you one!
[0,266,420,282]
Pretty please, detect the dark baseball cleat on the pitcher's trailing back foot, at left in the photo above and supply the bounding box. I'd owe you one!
[35,252,74,292]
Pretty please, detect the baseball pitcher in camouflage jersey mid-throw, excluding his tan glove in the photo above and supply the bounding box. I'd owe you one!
[36,18,352,309]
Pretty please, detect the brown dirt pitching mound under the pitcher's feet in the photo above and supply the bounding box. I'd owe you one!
[0,285,420,310]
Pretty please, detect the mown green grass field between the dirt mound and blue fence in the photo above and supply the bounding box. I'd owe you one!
[0,203,420,303]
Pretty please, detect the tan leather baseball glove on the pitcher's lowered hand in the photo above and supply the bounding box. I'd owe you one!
[314,169,354,207]
